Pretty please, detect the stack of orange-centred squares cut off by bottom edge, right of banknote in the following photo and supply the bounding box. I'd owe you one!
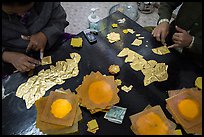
[129,105,176,135]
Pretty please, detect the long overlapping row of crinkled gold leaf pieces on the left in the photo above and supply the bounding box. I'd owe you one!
[16,53,81,109]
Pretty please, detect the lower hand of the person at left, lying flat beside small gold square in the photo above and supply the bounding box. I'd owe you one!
[2,51,40,72]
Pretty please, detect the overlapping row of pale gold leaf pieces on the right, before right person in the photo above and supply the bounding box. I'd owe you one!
[117,48,168,86]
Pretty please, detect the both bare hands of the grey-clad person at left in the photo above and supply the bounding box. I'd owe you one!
[2,32,47,72]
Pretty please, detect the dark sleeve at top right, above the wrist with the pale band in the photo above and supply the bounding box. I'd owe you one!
[157,2,182,23]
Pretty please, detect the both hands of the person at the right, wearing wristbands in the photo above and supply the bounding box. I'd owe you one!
[152,22,192,48]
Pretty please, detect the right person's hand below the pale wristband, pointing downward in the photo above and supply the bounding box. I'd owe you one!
[152,22,169,43]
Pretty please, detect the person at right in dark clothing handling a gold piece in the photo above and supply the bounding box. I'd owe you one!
[152,2,202,66]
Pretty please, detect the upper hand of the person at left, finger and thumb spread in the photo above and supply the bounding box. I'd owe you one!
[21,32,47,52]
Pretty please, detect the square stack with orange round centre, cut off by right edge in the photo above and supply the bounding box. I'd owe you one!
[166,88,202,135]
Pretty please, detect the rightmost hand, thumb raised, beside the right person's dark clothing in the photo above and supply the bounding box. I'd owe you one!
[168,26,193,48]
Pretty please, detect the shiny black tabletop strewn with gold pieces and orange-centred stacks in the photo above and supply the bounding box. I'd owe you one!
[2,12,201,135]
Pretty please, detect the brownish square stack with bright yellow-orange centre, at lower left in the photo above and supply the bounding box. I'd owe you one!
[35,89,82,134]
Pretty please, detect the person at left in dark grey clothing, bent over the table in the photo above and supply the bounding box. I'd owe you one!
[2,1,69,75]
